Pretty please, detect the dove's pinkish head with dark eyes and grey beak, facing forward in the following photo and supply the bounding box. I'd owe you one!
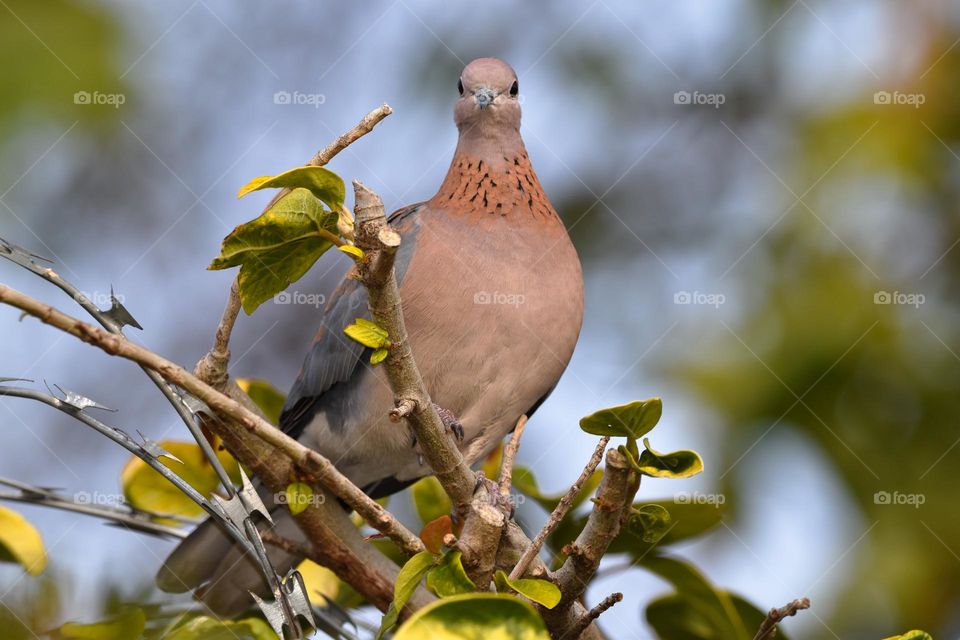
[454,58,520,131]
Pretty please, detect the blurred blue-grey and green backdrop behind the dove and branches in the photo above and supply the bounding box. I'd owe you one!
[0,0,960,639]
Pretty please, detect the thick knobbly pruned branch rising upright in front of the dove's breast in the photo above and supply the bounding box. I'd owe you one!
[353,180,477,514]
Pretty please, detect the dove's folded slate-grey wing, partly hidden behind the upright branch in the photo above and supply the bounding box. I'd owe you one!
[280,202,424,438]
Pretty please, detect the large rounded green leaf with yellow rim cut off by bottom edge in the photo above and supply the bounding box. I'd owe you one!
[394,593,550,640]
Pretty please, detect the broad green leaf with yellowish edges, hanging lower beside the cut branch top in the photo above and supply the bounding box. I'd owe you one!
[207,189,337,314]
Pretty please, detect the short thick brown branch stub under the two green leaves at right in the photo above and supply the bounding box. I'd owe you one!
[554,449,632,610]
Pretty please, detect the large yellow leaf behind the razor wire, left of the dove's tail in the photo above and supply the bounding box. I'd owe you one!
[120,440,240,517]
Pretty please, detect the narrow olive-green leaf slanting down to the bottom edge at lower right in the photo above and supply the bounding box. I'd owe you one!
[640,554,756,640]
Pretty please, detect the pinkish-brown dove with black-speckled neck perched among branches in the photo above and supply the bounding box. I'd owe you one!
[157,58,583,615]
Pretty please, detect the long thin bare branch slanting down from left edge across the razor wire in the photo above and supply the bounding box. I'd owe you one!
[0,284,424,553]
